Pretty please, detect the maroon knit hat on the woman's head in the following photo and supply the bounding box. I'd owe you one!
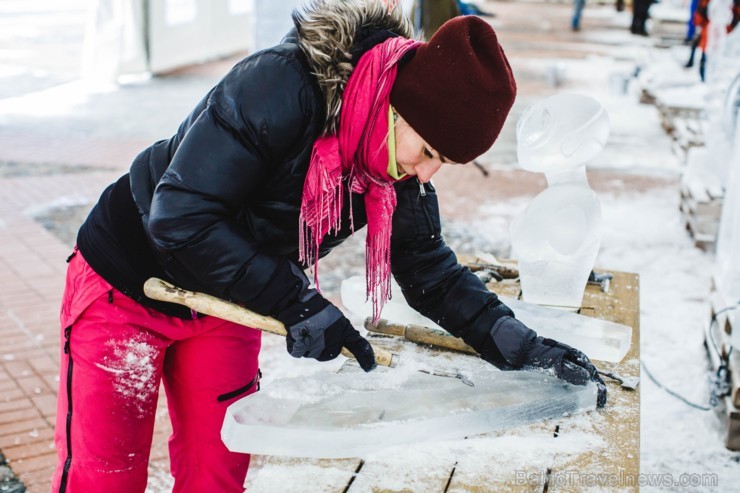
[391,15,516,163]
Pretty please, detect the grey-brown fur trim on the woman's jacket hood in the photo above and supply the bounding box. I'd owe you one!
[293,0,413,133]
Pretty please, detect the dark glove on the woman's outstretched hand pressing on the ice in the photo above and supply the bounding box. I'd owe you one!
[480,316,606,407]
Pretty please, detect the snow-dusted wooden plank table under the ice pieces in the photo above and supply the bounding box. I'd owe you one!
[247,272,640,493]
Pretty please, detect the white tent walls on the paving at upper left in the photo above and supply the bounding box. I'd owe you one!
[82,0,256,83]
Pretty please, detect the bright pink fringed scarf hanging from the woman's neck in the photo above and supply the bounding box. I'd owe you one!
[299,37,420,322]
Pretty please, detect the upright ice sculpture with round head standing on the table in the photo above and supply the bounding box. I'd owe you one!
[510,93,609,308]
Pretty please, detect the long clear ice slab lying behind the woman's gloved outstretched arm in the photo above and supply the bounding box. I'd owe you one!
[341,276,632,363]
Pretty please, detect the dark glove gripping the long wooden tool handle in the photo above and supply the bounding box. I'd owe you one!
[274,289,377,372]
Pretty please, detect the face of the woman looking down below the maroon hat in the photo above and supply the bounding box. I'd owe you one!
[395,111,449,183]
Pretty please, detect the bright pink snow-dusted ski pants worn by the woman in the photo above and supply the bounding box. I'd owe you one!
[52,252,261,493]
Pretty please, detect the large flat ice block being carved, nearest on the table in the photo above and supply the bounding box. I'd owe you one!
[221,362,596,458]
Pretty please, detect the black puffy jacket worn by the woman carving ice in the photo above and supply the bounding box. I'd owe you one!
[78,2,511,366]
